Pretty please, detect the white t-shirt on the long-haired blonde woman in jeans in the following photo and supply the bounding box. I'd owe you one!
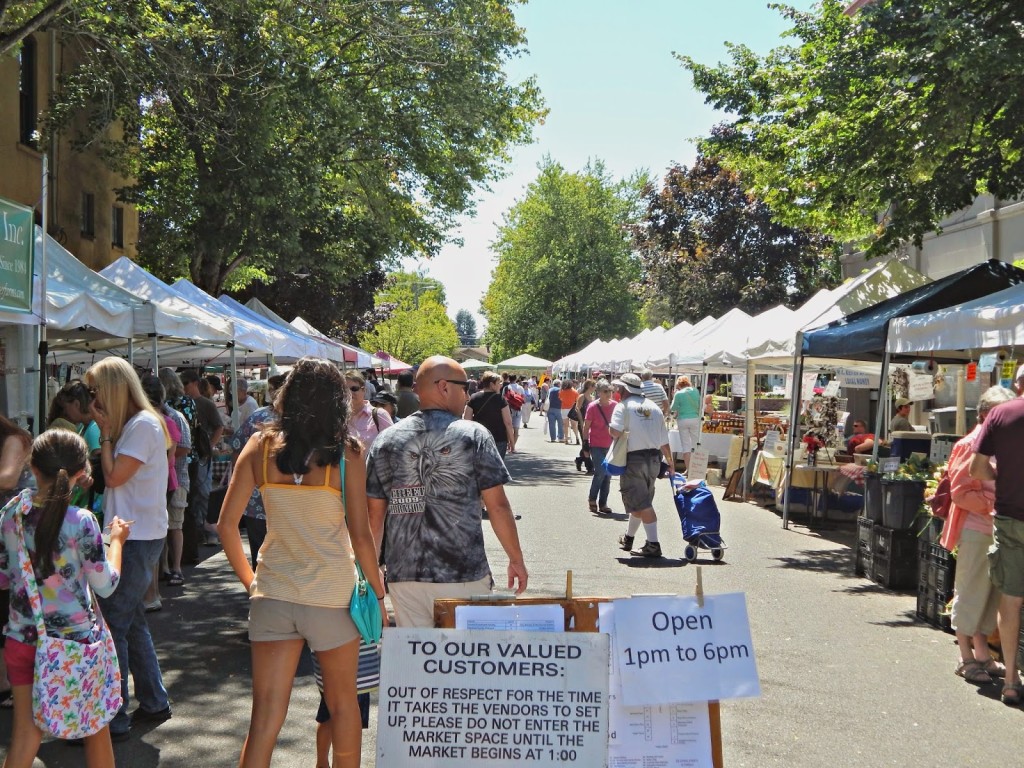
[103,411,167,542]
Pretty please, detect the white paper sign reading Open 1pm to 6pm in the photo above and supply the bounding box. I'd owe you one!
[612,593,761,707]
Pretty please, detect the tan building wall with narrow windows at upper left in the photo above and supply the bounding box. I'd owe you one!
[0,33,138,269]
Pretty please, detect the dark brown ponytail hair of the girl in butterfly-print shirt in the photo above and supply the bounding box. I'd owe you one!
[31,429,89,579]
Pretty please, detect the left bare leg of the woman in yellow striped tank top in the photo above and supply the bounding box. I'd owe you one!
[239,639,303,768]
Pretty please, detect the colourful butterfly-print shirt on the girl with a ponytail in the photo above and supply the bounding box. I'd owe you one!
[0,490,120,645]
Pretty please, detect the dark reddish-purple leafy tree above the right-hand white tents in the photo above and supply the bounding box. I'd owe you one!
[633,155,840,325]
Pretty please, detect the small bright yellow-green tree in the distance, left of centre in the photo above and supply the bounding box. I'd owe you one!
[358,272,459,365]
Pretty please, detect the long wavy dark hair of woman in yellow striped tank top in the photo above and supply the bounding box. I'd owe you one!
[263,357,361,475]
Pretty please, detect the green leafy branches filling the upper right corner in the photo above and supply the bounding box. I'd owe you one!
[681,0,1024,259]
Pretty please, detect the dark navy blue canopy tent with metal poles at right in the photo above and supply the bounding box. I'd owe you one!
[782,259,1024,527]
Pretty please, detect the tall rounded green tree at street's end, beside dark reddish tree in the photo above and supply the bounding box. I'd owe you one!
[481,158,640,359]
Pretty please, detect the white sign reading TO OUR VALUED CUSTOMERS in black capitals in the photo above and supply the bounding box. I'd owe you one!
[377,628,609,768]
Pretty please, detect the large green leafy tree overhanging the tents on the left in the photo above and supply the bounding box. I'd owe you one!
[43,0,543,309]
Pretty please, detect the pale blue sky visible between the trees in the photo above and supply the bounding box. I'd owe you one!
[404,0,812,331]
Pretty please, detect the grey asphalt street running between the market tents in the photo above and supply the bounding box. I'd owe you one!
[0,415,1024,768]
